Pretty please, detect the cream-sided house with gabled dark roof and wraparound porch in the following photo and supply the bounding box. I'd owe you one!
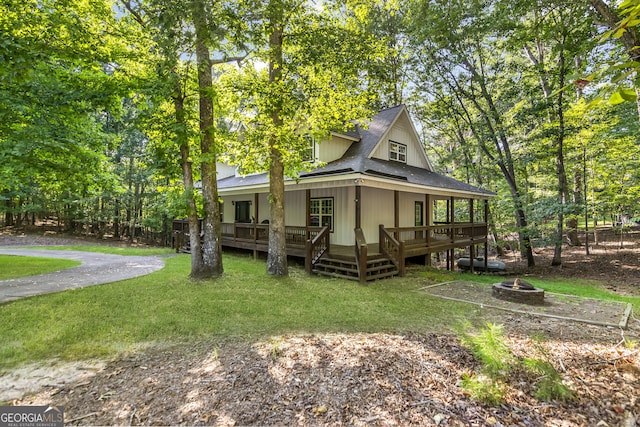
[174,105,494,281]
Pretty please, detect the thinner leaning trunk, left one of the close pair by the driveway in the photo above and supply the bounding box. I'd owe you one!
[173,77,203,277]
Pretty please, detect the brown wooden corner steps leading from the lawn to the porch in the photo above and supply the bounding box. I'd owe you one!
[311,254,399,282]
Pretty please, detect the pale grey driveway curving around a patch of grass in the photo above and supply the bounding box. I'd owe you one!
[0,247,164,303]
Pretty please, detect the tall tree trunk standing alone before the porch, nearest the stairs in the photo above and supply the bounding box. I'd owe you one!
[267,17,288,276]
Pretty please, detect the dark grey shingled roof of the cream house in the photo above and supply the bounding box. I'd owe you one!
[218,105,495,196]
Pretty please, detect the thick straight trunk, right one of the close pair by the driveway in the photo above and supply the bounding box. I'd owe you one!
[192,0,223,277]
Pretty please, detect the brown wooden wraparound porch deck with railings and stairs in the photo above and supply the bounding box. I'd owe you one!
[173,195,488,282]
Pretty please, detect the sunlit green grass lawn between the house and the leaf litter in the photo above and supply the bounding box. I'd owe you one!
[0,254,640,370]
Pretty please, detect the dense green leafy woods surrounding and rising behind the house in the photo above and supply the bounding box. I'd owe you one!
[0,0,640,277]
